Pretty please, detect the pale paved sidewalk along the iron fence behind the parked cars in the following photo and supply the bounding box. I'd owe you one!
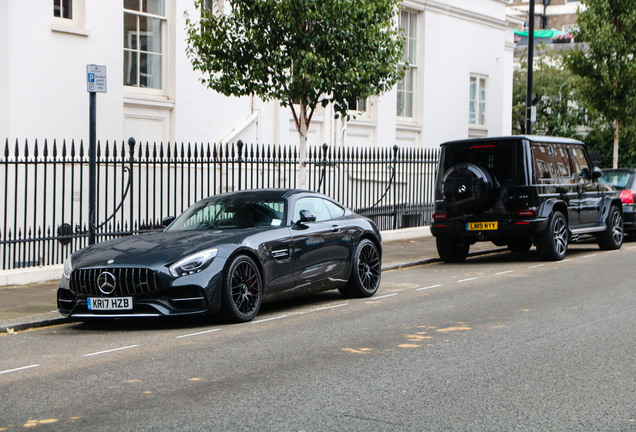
[0,235,501,333]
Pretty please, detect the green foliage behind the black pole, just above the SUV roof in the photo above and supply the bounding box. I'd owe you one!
[512,50,590,138]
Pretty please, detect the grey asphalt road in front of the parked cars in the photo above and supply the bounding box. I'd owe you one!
[0,243,636,431]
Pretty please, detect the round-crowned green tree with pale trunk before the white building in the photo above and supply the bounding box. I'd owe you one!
[186,0,404,187]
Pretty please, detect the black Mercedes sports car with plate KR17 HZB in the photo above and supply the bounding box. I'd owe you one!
[57,189,382,322]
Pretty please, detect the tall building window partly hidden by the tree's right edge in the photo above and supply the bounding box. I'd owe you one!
[397,11,417,117]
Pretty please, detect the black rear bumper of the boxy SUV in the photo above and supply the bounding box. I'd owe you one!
[431,218,548,243]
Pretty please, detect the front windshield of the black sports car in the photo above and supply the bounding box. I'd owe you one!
[168,196,285,231]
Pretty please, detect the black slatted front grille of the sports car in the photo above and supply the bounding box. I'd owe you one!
[70,268,159,296]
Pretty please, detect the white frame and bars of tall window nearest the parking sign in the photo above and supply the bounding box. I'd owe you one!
[122,0,170,96]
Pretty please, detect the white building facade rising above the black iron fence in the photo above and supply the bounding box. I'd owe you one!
[0,0,519,148]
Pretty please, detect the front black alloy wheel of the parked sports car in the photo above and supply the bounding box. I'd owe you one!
[222,255,263,322]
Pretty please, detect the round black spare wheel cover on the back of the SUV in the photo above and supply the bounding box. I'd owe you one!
[442,163,494,214]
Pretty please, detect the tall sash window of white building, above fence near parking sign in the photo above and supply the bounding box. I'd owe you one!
[124,0,166,89]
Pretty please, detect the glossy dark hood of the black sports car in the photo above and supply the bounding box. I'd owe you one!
[72,229,250,268]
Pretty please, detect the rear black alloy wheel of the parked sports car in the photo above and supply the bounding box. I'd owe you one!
[339,239,382,297]
